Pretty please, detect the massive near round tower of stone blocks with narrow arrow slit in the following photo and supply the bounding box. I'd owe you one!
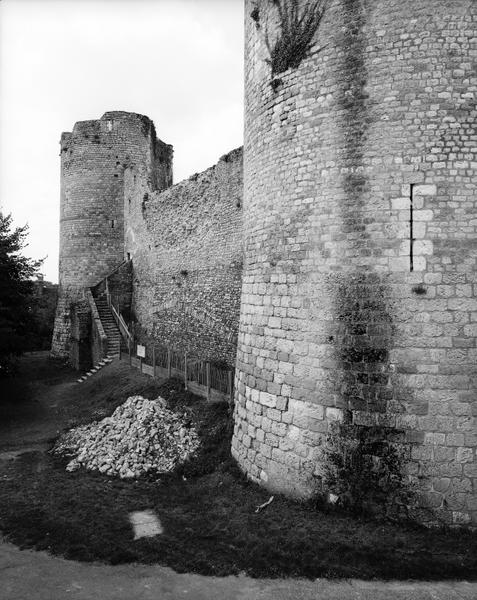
[233,0,477,525]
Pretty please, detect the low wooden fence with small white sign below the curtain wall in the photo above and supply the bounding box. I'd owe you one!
[121,343,234,402]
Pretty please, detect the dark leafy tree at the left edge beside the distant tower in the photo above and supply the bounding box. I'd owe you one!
[0,212,43,377]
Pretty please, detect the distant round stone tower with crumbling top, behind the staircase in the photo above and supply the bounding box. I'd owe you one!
[52,111,172,356]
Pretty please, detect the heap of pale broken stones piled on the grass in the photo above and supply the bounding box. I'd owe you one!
[52,396,199,478]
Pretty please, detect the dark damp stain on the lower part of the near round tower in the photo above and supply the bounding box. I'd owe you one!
[330,273,419,519]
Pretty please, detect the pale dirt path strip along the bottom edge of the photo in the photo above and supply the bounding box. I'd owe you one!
[0,544,477,600]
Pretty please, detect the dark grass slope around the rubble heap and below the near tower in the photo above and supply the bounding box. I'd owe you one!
[0,354,477,580]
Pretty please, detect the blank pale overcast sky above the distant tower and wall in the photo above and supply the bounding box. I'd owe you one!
[0,0,243,282]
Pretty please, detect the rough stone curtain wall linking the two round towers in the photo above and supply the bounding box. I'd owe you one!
[124,149,243,366]
